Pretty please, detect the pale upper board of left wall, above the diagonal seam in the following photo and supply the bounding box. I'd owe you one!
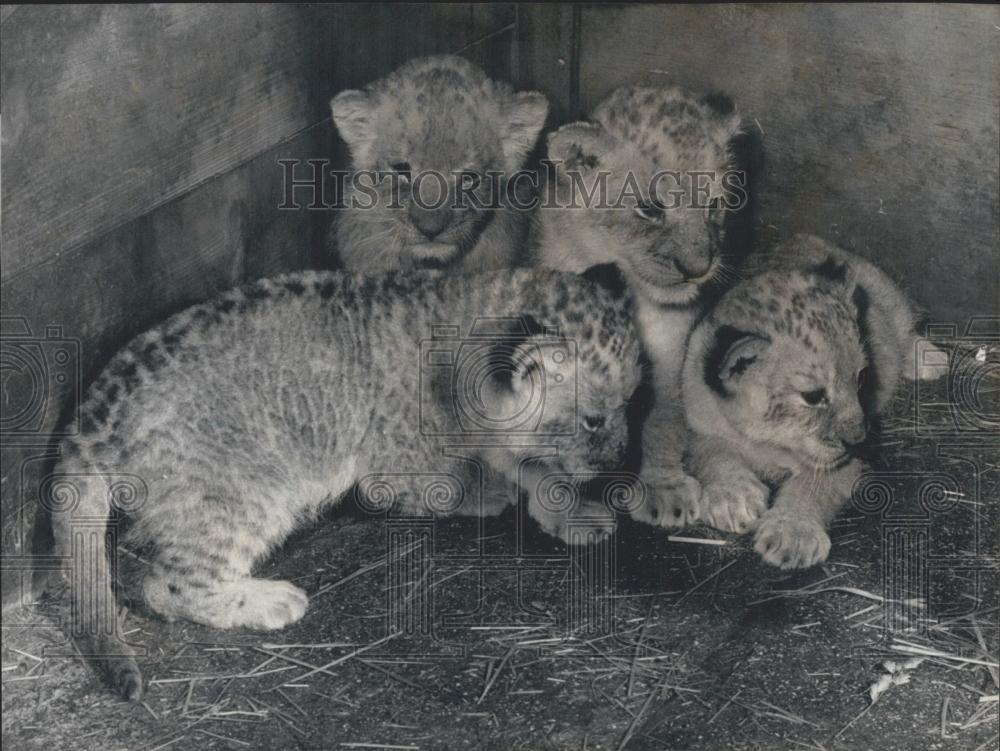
[0,4,323,279]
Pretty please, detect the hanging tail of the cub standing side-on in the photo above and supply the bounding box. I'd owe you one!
[47,461,145,701]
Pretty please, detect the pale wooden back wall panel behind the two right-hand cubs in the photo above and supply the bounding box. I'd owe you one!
[536,4,1000,323]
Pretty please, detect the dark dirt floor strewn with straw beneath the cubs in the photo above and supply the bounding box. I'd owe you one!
[3,382,1000,751]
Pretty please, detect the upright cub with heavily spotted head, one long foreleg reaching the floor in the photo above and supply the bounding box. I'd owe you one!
[533,85,747,527]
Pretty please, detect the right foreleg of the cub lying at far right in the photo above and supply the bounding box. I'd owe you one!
[754,460,863,569]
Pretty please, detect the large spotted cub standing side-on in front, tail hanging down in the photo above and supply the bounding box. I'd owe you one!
[52,270,639,698]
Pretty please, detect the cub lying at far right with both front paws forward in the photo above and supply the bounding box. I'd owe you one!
[683,235,935,569]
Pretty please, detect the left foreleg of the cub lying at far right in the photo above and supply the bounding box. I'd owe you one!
[691,436,771,534]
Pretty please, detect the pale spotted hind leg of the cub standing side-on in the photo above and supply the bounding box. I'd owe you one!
[139,484,318,630]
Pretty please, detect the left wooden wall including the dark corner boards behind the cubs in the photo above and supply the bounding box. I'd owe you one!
[0,4,514,603]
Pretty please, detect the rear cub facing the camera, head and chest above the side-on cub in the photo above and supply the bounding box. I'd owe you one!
[330,55,548,272]
